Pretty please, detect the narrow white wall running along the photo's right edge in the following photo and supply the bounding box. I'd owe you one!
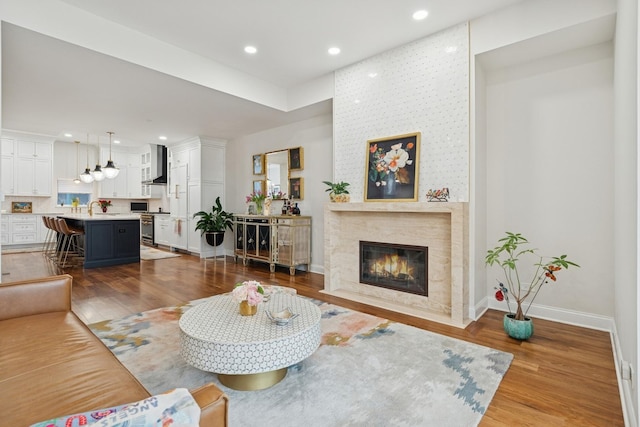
[612,0,640,426]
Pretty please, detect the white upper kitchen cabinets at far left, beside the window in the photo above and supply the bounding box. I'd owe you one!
[0,134,53,197]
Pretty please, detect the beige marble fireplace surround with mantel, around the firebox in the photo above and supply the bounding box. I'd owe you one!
[322,202,470,328]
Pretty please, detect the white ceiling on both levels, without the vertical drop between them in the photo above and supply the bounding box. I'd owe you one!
[2,0,524,145]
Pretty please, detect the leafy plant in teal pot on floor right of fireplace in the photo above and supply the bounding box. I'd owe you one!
[485,232,580,339]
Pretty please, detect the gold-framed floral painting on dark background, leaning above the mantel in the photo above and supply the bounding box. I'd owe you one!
[364,132,420,202]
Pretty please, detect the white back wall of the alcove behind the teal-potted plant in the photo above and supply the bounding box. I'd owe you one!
[485,43,614,317]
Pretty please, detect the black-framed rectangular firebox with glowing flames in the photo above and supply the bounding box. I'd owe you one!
[360,241,429,296]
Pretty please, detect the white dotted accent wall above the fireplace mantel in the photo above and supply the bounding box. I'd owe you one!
[333,23,469,202]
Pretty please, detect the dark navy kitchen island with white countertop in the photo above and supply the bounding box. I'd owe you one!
[58,213,140,268]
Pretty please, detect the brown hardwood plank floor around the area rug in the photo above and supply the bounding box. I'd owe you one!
[2,252,624,426]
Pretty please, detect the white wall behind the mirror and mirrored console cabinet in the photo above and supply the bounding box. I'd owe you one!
[224,115,333,273]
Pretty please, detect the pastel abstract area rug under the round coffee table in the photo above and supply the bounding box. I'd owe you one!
[90,299,513,427]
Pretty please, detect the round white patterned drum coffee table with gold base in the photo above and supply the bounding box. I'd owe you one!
[179,293,322,390]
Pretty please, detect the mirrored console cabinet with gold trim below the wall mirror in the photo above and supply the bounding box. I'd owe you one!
[233,214,311,276]
